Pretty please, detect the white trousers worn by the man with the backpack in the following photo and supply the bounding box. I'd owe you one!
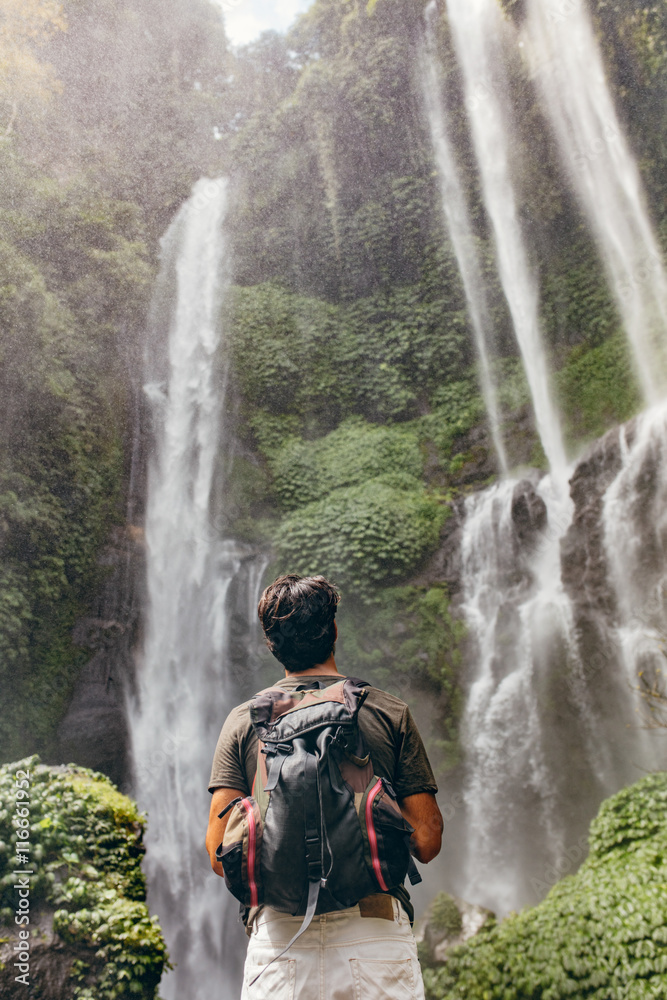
[241,898,424,1000]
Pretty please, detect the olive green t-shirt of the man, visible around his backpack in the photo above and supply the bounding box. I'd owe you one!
[208,674,438,799]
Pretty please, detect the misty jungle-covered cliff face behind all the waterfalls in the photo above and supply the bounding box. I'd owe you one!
[0,0,667,761]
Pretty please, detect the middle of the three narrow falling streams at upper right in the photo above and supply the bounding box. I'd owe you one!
[447,0,566,484]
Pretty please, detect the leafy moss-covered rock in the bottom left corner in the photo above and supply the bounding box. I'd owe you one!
[0,756,168,1000]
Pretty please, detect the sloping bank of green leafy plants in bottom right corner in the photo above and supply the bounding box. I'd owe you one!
[424,773,667,1000]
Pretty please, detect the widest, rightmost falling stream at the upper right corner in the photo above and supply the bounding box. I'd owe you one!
[527,0,667,403]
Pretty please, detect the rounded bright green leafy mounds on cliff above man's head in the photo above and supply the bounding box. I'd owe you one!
[269,418,447,596]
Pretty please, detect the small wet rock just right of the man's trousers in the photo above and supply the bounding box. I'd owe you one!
[415,892,495,965]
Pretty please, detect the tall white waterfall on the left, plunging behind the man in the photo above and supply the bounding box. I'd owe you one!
[129,179,261,1000]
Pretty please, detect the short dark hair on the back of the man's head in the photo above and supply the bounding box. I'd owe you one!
[257,573,340,673]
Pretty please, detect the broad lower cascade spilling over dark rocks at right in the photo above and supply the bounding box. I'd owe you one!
[456,402,667,914]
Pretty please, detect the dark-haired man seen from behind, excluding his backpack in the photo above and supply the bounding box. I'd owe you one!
[206,575,443,1000]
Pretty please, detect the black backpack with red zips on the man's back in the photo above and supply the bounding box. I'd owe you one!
[216,677,421,968]
